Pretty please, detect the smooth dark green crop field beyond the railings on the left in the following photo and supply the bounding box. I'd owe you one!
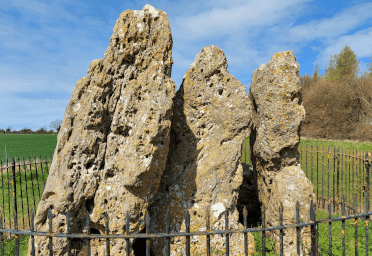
[0,134,57,165]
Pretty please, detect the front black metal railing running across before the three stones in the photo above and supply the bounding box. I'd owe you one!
[0,195,372,256]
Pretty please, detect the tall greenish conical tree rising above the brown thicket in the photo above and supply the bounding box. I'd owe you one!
[326,45,360,81]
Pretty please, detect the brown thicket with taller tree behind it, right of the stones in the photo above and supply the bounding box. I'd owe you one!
[300,45,372,141]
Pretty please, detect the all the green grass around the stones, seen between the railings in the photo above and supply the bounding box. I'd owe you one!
[0,135,372,255]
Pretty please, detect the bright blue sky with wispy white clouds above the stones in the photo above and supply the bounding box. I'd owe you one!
[0,0,372,131]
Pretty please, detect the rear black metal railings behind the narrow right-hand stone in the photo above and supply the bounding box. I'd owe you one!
[242,140,372,214]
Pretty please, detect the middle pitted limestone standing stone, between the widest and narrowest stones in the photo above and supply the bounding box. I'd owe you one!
[149,45,255,255]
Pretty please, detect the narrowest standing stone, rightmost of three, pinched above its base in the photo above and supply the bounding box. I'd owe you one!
[249,51,315,255]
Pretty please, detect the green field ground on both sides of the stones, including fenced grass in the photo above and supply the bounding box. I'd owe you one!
[0,134,372,255]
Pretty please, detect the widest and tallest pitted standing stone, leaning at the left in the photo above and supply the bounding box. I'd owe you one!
[29,5,176,255]
